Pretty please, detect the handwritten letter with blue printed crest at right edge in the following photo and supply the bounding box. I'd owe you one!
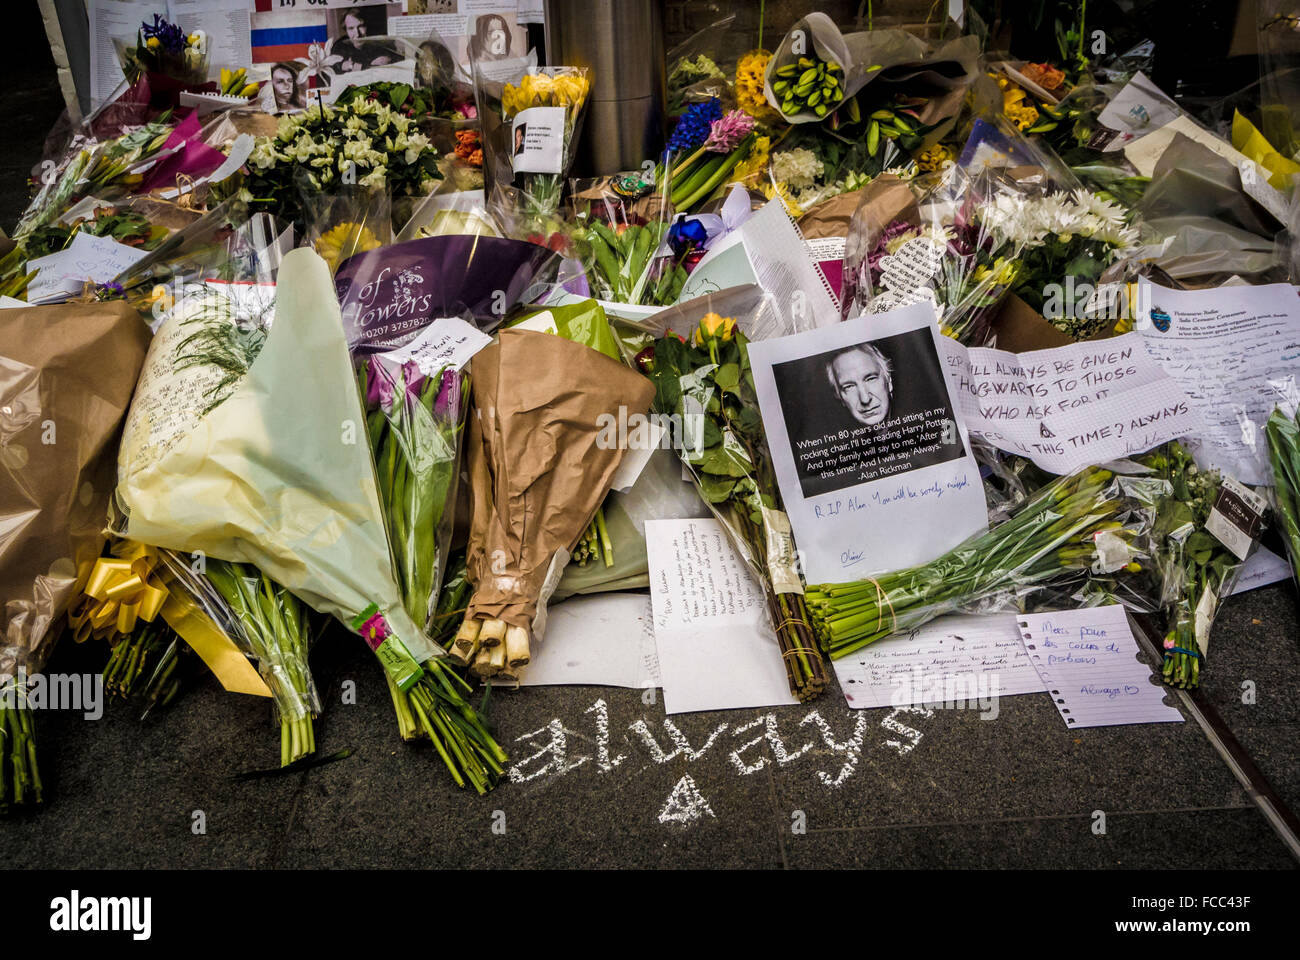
[1138,280,1300,487]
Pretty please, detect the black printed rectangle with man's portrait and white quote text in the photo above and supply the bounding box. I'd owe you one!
[772,329,965,497]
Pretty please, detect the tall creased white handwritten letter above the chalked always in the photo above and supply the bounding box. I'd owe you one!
[646,519,798,714]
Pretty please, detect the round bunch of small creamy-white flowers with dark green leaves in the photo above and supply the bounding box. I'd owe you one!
[242,99,442,224]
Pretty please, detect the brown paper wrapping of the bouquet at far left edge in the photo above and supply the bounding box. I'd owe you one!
[0,302,150,674]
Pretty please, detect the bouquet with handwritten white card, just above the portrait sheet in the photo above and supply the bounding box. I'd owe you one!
[841,165,1023,346]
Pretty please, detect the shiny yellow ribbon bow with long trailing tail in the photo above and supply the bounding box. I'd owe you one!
[68,540,270,697]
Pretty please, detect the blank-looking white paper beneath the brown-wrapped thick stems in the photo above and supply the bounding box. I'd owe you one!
[519,593,659,689]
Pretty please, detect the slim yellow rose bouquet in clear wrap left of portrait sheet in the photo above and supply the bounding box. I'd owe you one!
[638,313,827,701]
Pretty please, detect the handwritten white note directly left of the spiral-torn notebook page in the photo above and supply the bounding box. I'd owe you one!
[833,614,1047,713]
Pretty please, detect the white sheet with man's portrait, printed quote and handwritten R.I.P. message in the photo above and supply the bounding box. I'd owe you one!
[749,304,987,583]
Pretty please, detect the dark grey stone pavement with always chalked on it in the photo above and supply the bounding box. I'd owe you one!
[0,44,1300,869]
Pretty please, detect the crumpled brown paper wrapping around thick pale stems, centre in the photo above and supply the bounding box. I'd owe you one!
[465,329,654,630]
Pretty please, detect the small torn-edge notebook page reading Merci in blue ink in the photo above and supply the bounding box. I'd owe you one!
[1018,604,1183,727]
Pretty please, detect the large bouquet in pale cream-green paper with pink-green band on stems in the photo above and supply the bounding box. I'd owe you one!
[113,250,504,792]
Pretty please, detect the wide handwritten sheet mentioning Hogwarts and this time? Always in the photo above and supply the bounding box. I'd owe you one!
[940,333,1201,473]
